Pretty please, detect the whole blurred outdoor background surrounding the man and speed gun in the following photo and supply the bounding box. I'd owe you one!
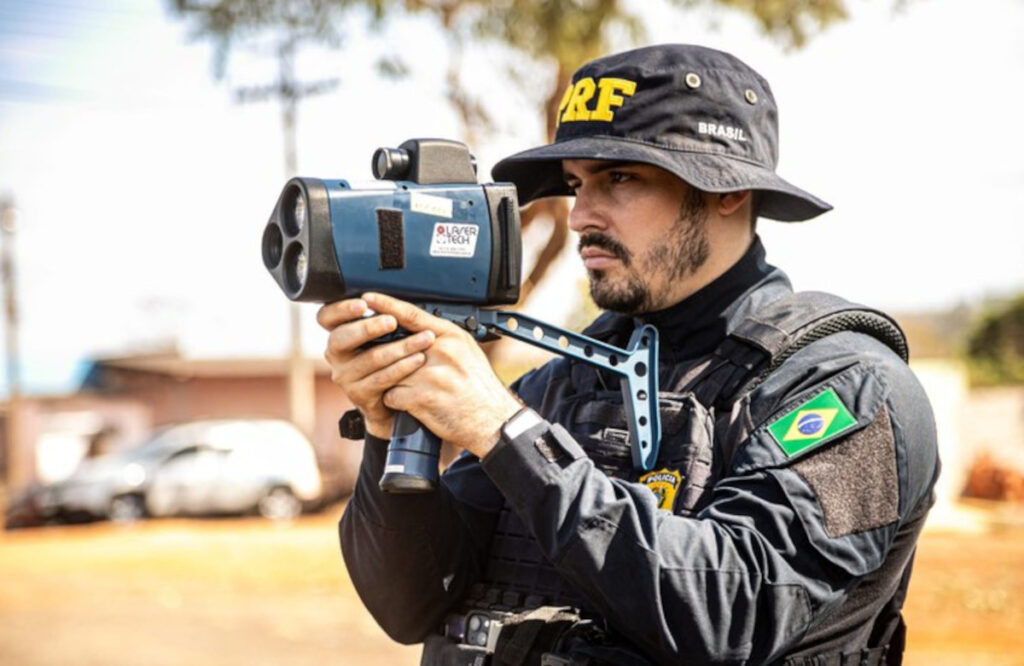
[0,0,1024,664]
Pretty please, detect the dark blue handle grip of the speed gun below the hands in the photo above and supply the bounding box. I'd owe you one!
[380,412,441,494]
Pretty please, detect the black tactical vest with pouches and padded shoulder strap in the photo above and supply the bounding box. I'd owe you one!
[438,292,907,663]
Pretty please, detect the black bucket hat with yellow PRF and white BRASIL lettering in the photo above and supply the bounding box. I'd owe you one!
[492,44,831,221]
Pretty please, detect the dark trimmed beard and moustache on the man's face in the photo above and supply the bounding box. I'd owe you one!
[579,188,711,315]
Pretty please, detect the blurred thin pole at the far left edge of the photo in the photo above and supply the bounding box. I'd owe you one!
[0,197,29,493]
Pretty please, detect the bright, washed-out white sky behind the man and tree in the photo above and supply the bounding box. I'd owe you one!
[0,0,1024,392]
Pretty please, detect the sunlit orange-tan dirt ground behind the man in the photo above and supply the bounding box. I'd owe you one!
[0,500,1024,666]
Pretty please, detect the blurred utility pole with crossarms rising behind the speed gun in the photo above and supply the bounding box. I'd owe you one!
[236,33,338,436]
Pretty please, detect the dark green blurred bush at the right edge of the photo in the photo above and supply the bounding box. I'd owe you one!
[967,294,1024,384]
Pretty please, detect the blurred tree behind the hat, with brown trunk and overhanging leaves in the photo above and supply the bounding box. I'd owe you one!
[169,0,851,299]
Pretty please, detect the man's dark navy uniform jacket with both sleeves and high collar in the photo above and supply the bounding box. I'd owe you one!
[340,241,939,664]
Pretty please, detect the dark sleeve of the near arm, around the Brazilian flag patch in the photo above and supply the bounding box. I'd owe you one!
[482,334,937,663]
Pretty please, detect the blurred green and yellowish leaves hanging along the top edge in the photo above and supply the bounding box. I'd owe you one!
[174,0,847,94]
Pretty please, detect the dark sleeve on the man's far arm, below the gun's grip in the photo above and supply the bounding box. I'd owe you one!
[339,368,544,643]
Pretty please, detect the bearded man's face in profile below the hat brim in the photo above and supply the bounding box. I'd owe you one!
[562,160,710,315]
